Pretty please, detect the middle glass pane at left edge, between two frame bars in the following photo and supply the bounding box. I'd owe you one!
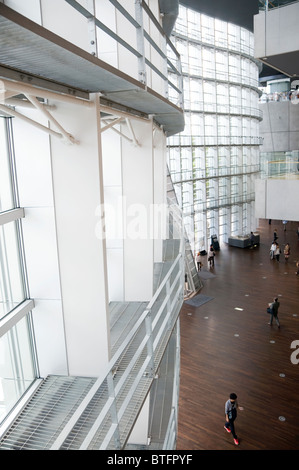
[0,222,25,318]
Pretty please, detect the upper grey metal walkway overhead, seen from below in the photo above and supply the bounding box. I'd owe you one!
[0,3,184,136]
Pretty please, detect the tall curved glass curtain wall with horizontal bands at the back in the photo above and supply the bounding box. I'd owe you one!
[168,6,261,251]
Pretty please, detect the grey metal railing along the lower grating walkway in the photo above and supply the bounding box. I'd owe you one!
[50,203,184,450]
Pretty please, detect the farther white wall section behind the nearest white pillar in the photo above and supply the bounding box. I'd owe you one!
[102,118,167,302]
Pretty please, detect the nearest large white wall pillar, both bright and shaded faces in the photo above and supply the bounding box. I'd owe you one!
[13,92,109,376]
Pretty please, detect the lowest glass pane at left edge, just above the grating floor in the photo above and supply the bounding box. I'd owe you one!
[0,317,35,422]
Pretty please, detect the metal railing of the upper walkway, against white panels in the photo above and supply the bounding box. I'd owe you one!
[65,0,183,108]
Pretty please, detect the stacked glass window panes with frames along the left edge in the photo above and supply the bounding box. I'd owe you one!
[0,117,37,424]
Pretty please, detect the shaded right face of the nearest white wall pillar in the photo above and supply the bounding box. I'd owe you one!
[51,96,109,376]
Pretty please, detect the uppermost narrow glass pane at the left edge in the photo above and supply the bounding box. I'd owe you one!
[0,118,14,212]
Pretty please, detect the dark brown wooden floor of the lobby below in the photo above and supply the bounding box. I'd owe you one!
[177,220,299,451]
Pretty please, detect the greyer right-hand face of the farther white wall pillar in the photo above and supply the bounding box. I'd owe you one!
[121,121,154,301]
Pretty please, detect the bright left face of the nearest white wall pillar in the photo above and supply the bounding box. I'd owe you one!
[13,109,68,377]
